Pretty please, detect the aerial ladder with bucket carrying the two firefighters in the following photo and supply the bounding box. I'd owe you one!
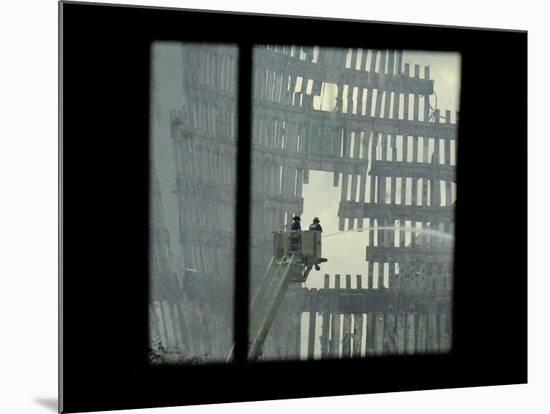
[227,231,327,362]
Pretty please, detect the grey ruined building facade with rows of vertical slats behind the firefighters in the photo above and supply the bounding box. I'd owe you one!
[151,44,457,360]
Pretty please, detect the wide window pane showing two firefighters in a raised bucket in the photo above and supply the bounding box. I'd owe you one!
[249,45,460,360]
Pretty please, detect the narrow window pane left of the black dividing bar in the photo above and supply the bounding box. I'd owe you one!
[149,42,238,364]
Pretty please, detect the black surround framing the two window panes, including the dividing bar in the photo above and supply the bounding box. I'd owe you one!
[60,3,527,412]
